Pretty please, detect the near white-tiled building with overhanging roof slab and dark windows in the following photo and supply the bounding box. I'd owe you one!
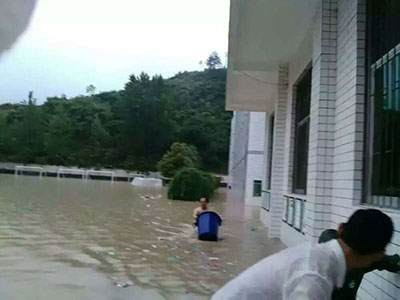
[226,0,400,300]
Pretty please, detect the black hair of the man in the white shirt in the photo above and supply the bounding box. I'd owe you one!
[339,209,394,255]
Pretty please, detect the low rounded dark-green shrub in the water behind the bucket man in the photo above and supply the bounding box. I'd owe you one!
[168,168,218,201]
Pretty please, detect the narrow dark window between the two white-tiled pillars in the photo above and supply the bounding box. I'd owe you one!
[293,68,311,194]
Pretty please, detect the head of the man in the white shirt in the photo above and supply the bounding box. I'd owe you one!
[338,209,394,268]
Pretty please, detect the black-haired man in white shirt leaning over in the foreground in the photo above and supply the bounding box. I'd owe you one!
[212,209,393,300]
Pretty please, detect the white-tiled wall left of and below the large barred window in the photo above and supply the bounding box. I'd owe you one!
[331,0,400,300]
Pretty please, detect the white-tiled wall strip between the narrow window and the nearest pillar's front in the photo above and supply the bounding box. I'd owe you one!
[304,0,337,240]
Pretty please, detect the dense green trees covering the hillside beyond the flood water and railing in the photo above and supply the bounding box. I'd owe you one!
[0,69,231,172]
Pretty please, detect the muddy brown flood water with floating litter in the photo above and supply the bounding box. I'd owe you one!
[0,175,283,300]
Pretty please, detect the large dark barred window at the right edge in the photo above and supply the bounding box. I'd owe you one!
[364,0,400,208]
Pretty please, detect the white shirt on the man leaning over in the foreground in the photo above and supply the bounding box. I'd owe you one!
[212,240,346,300]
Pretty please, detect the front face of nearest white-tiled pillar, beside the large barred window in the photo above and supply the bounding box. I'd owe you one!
[331,0,365,219]
